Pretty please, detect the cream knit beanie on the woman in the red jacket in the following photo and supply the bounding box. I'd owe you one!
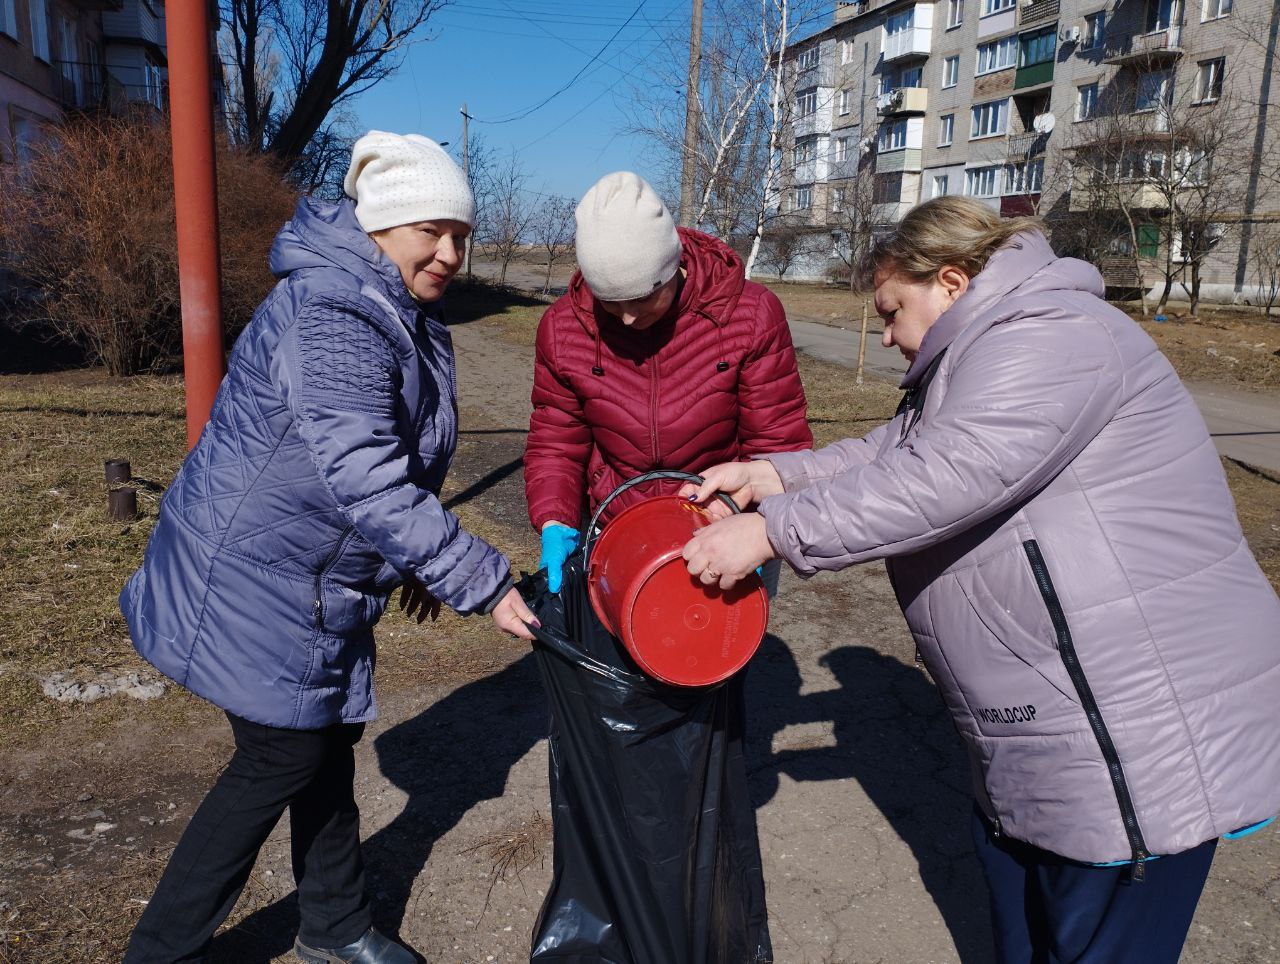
[576,170,681,301]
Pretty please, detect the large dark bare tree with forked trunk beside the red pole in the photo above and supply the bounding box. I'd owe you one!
[220,0,448,186]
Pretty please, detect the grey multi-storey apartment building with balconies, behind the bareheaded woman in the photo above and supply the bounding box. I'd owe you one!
[777,0,1280,300]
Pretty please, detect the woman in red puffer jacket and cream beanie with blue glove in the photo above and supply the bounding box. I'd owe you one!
[525,172,813,591]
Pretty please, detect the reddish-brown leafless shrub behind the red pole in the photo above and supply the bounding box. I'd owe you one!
[0,118,297,375]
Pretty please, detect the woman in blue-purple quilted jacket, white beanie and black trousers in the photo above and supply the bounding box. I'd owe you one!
[120,131,535,964]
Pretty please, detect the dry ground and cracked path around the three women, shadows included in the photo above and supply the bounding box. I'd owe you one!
[0,284,1280,964]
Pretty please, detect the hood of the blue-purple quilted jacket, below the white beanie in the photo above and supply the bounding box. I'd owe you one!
[269,197,421,310]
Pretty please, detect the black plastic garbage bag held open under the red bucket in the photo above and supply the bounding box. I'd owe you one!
[520,558,773,964]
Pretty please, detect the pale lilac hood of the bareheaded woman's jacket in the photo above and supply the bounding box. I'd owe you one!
[900,230,1106,388]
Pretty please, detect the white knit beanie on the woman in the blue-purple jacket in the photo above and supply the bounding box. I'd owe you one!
[343,131,476,232]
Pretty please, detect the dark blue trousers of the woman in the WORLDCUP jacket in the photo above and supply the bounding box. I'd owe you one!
[973,809,1217,964]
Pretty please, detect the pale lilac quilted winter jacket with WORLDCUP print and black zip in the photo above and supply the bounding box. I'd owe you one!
[760,233,1280,862]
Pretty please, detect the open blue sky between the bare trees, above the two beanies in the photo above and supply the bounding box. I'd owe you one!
[349,0,690,197]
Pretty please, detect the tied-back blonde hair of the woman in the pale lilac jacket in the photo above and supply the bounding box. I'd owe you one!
[859,196,1043,287]
